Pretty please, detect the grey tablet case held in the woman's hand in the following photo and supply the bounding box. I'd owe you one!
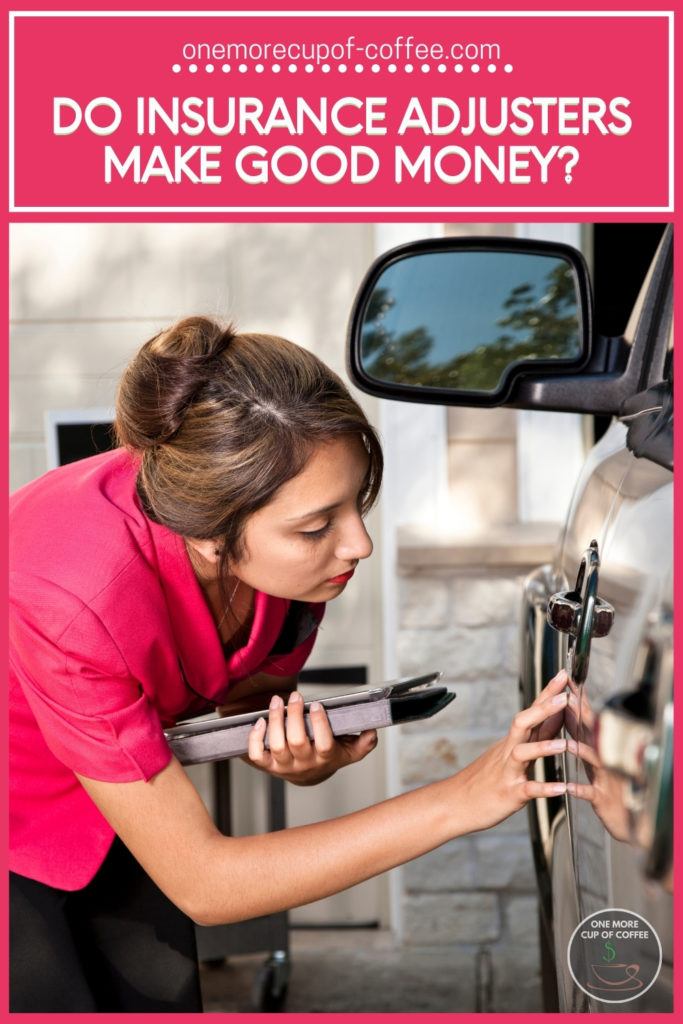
[165,672,456,765]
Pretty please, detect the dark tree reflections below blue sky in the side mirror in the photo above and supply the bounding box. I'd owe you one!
[362,262,580,391]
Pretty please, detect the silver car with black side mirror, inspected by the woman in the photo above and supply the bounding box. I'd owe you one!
[348,226,674,1013]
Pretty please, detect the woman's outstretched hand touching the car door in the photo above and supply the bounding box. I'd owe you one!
[454,670,583,831]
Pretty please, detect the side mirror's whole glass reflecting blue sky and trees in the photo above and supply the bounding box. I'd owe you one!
[360,251,582,392]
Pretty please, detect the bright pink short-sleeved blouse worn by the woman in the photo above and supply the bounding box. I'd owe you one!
[9,449,325,890]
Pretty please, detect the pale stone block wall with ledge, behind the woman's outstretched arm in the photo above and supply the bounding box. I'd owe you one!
[398,524,556,1012]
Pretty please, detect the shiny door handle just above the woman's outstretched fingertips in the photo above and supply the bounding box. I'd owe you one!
[547,541,614,683]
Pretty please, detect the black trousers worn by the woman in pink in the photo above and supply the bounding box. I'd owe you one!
[9,839,202,1013]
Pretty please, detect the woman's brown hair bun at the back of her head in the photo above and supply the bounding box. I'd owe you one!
[116,316,236,452]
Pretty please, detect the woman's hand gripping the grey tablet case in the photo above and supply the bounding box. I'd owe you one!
[245,690,377,785]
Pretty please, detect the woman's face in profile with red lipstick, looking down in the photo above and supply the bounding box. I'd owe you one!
[230,436,373,601]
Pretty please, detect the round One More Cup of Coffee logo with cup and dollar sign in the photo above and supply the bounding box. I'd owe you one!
[567,907,661,1002]
